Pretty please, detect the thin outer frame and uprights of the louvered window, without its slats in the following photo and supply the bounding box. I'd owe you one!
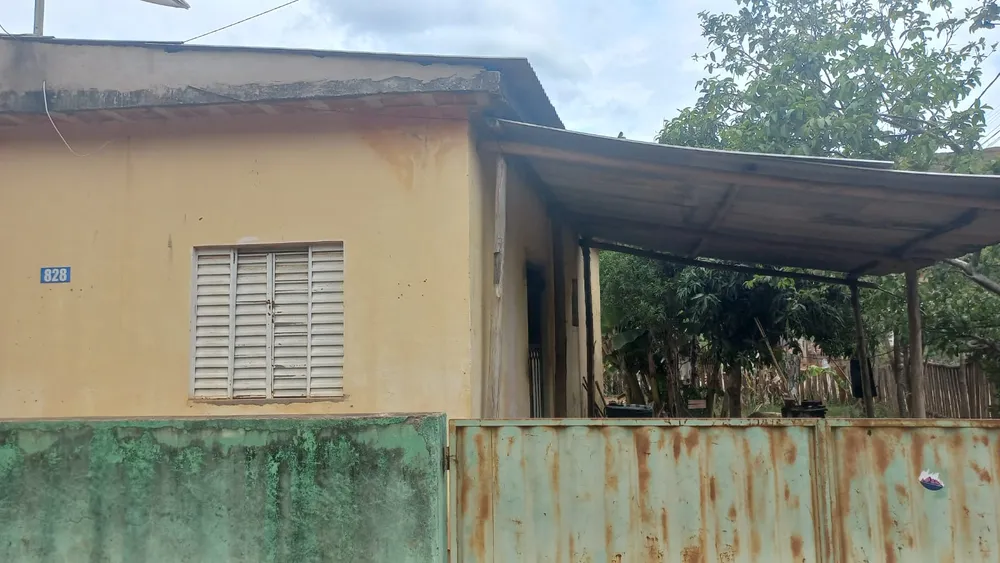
[188,240,348,405]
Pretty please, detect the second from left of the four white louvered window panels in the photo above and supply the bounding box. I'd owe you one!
[230,252,270,399]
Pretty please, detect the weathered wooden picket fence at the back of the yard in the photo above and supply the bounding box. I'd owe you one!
[798,362,996,418]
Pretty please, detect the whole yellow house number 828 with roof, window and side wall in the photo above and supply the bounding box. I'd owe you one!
[0,38,600,418]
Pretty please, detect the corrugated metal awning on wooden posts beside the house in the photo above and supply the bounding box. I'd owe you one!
[491,120,1000,274]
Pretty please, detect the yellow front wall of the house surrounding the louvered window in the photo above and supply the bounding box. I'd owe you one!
[0,115,481,418]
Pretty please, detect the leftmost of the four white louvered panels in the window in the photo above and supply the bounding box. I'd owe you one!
[192,250,233,399]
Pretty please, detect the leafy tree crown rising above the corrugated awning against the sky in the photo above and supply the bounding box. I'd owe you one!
[659,0,997,170]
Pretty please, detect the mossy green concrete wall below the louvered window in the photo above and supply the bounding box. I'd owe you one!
[0,415,447,563]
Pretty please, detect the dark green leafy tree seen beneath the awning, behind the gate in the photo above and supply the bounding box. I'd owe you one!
[600,252,853,416]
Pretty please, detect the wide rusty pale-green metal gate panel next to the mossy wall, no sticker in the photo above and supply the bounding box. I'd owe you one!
[451,420,821,563]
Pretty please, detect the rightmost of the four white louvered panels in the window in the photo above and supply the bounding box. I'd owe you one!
[308,244,344,397]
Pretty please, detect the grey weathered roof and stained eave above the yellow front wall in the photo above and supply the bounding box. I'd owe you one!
[0,36,562,127]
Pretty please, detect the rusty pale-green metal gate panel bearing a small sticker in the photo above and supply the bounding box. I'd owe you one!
[828,420,1000,563]
